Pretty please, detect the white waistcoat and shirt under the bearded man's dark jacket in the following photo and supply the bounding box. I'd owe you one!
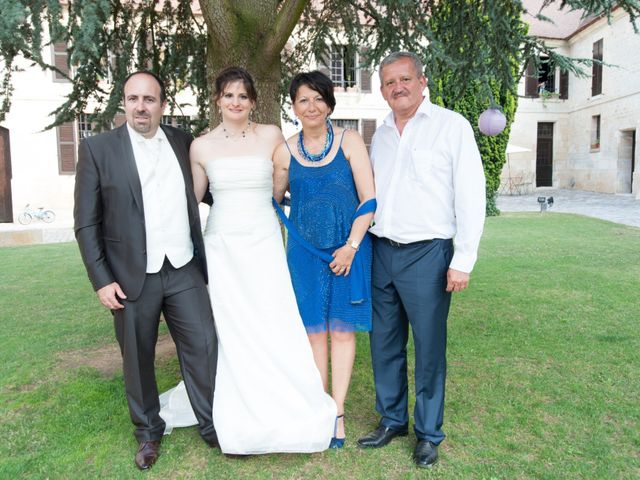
[127,124,193,273]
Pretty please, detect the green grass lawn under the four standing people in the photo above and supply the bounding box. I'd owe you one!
[0,213,640,479]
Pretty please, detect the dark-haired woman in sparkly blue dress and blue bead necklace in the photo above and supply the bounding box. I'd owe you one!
[274,71,375,448]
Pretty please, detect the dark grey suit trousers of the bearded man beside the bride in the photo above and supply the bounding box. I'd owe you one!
[114,259,218,441]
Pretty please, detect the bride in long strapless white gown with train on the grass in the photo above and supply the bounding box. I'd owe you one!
[160,68,336,454]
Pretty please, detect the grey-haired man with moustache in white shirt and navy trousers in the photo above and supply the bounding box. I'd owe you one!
[358,52,485,467]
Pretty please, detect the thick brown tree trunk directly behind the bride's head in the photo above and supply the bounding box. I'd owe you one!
[200,0,309,127]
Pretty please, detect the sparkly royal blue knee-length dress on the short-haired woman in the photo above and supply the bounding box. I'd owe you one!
[287,146,372,333]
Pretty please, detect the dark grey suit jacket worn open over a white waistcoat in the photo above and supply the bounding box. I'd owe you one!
[73,124,207,300]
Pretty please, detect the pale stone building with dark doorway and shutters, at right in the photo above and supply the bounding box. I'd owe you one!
[501,0,640,199]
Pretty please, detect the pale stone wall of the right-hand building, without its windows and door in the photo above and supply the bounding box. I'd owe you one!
[502,10,640,198]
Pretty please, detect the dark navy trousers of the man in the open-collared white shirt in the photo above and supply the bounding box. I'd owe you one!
[370,237,453,445]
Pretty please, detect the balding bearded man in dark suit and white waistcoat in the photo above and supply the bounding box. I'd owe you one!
[74,71,217,470]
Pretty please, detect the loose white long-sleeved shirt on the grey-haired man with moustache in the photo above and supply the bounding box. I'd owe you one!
[371,97,486,272]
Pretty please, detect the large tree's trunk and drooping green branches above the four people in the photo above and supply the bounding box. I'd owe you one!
[0,0,640,131]
